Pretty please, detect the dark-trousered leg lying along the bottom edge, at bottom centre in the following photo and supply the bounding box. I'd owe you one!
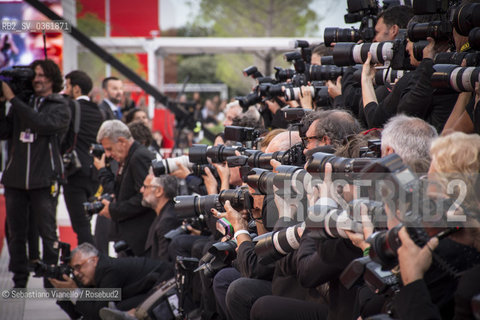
[250,296,328,320]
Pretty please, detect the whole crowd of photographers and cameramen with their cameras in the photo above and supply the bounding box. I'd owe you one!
[0,0,480,320]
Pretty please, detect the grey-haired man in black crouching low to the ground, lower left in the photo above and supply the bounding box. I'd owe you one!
[49,243,173,319]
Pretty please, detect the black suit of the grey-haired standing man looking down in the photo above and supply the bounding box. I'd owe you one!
[99,141,156,256]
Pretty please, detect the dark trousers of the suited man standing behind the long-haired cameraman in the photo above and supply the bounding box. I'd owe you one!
[63,177,96,244]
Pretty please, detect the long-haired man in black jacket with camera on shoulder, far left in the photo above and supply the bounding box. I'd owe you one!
[0,60,71,288]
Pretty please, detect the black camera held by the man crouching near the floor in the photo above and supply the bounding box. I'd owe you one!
[34,241,73,281]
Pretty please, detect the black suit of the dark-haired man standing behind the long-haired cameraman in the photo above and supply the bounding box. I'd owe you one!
[63,99,103,244]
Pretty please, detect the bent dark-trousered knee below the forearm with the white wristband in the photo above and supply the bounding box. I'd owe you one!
[226,278,272,320]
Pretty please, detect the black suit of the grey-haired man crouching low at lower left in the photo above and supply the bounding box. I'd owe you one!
[76,255,173,319]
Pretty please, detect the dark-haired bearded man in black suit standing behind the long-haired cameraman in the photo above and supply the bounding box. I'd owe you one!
[62,70,104,244]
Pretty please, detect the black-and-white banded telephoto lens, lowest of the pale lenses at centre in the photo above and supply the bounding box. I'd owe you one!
[253,222,305,265]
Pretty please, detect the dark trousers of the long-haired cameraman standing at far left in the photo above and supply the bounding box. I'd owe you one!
[5,188,58,287]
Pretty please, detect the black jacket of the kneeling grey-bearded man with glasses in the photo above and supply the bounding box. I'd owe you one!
[145,201,181,261]
